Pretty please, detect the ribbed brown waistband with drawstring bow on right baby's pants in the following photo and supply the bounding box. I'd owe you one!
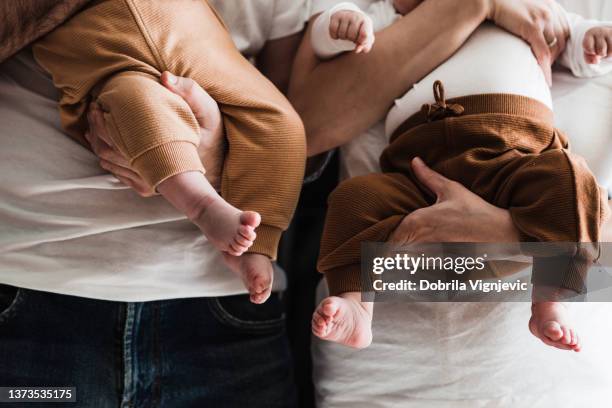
[391,94,553,140]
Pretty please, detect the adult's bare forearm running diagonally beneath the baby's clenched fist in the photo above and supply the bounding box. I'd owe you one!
[289,0,488,155]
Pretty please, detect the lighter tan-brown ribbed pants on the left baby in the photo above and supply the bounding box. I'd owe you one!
[34,0,306,259]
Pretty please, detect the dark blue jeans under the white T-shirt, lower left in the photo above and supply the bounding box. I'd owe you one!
[0,285,297,408]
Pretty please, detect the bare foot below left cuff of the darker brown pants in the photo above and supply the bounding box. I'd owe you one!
[312,292,372,348]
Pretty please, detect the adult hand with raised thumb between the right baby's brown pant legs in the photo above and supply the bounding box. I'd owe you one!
[389,158,520,245]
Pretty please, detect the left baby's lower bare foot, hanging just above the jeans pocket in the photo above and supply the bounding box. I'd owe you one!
[223,254,274,304]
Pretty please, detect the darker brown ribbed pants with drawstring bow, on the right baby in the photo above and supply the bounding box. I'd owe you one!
[318,95,605,294]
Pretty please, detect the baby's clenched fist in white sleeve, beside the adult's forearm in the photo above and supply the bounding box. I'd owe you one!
[329,10,374,54]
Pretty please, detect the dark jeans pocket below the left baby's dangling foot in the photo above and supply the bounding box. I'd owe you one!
[208,293,285,334]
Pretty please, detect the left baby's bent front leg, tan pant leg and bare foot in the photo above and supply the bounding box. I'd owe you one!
[98,72,260,255]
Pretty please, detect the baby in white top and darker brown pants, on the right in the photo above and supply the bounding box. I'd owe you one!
[311,0,612,351]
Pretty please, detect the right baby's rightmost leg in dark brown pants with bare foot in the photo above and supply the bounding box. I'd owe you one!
[499,149,607,351]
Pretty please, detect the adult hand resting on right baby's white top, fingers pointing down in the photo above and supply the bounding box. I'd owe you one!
[487,0,569,85]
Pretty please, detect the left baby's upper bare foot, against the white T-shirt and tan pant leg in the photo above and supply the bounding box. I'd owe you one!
[192,196,261,256]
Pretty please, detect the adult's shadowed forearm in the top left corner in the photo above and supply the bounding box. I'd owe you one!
[0,0,89,62]
